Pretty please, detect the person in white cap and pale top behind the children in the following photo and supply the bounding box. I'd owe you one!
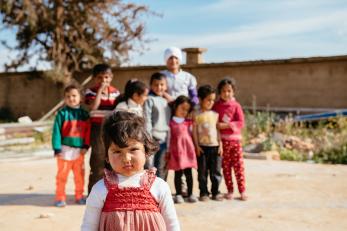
[161,47,199,104]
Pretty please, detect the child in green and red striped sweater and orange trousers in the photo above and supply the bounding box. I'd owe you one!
[52,85,90,207]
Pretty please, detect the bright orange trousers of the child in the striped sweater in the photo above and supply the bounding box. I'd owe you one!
[55,155,84,201]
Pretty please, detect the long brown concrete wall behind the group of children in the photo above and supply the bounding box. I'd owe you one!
[0,56,347,119]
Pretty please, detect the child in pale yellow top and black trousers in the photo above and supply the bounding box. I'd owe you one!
[193,85,223,201]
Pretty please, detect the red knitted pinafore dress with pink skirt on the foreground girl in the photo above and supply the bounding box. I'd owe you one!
[99,170,166,231]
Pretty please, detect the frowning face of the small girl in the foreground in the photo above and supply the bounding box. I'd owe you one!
[108,139,146,176]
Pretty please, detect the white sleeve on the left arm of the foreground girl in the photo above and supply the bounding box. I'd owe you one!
[81,180,107,231]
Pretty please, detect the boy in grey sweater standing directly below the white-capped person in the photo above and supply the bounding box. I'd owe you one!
[144,72,170,180]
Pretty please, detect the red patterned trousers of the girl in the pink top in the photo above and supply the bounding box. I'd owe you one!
[222,140,246,193]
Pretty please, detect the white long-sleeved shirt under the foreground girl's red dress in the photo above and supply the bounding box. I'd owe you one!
[81,171,180,231]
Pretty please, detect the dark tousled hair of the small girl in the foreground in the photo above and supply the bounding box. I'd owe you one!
[102,111,159,170]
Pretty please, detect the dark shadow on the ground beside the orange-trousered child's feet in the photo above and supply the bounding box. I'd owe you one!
[0,193,79,207]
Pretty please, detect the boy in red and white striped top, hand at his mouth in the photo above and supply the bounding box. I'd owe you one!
[85,64,119,193]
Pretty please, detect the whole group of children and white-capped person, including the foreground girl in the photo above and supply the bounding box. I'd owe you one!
[52,47,247,230]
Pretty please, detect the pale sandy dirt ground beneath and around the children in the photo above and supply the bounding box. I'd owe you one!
[0,153,347,231]
